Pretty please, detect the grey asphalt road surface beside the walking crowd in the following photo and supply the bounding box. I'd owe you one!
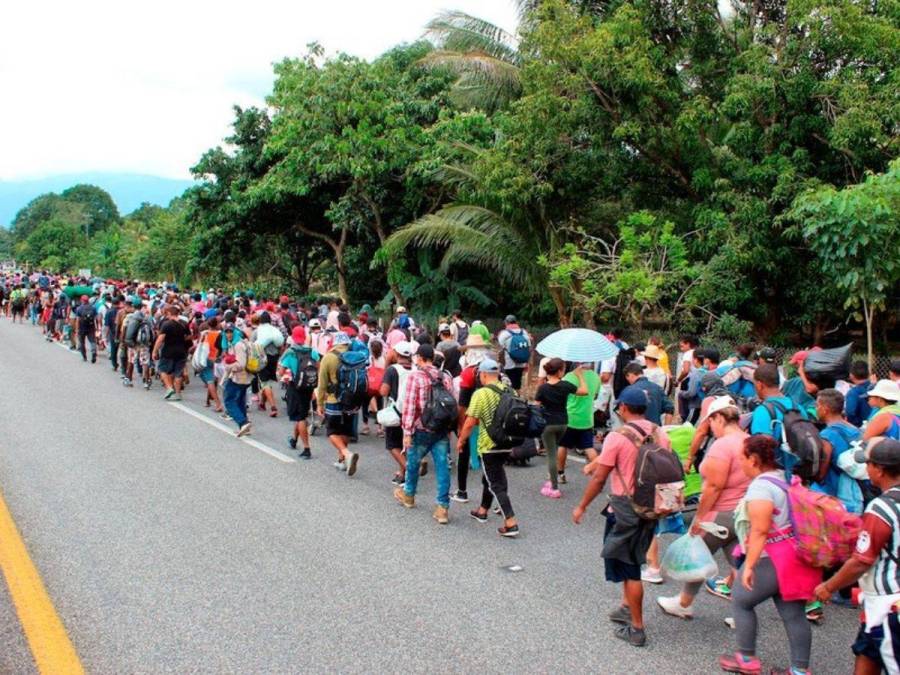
[0,319,855,674]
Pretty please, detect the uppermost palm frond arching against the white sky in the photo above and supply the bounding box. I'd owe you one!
[425,11,522,66]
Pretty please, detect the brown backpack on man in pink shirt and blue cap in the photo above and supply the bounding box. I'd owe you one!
[615,422,684,520]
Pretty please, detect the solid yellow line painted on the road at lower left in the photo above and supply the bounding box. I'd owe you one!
[0,494,84,675]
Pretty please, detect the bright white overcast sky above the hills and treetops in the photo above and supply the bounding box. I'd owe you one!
[0,0,516,180]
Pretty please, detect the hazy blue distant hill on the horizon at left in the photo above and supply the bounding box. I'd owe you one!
[0,173,194,227]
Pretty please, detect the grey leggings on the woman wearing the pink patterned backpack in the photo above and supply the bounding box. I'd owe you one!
[731,558,812,670]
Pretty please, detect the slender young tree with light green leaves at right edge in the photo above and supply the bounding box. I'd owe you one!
[789,160,900,368]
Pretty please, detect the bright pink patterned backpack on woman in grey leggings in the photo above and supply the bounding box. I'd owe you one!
[763,476,862,567]
